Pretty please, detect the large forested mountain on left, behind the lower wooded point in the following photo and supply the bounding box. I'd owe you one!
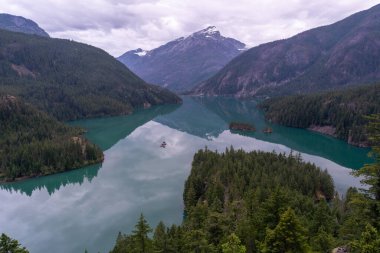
[0,30,180,120]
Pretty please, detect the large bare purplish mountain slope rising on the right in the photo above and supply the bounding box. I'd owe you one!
[192,5,380,96]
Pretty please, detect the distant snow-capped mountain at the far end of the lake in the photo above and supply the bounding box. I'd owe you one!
[118,26,245,92]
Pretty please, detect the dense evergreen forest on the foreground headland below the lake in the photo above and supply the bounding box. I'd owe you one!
[111,148,380,253]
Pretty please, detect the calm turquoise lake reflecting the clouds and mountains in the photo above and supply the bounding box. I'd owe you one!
[0,97,369,253]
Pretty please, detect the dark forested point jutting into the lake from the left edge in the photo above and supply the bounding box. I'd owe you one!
[0,95,103,181]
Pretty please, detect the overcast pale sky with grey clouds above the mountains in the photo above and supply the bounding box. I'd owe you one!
[0,0,380,56]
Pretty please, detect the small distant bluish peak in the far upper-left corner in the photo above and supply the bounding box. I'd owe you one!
[0,13,49,37]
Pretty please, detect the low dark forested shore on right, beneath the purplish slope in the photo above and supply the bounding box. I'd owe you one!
[261,84,380,146]
